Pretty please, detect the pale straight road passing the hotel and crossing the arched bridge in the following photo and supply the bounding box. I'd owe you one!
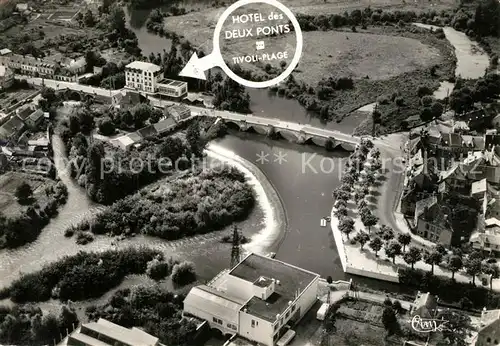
[21,75,360,144]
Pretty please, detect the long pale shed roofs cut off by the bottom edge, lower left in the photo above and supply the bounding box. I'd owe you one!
[62,318,161,346]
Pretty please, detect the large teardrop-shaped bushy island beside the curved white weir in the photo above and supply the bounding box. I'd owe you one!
[73,166,255,240]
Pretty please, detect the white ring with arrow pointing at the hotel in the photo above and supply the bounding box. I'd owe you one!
[179,0,303,88]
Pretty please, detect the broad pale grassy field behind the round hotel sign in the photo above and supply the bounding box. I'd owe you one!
[166,10,442,85]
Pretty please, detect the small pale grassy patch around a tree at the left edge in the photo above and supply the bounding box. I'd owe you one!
[0,172,51,217]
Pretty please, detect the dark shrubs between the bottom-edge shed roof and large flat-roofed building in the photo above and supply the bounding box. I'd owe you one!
[86,286,196,346]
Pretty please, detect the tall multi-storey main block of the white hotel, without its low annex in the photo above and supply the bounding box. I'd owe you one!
[125,61,163,93]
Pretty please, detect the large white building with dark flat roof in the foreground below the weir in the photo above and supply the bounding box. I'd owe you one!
[184,254,320,346]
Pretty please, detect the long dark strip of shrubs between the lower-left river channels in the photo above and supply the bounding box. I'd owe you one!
[4,248,161,303]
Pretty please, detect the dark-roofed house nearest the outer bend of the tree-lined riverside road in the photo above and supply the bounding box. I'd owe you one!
[414,196,453,246]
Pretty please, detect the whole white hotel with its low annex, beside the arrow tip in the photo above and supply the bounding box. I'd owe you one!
[125,61,188,98]
